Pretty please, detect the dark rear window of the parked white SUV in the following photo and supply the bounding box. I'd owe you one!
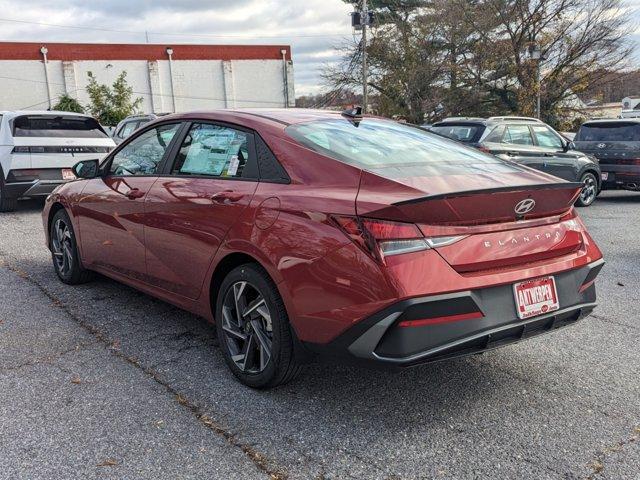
[13,115,108,138]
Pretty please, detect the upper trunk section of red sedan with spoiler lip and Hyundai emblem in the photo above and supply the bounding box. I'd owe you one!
[356,168,582,227]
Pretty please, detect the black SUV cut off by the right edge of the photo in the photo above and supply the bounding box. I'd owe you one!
[575,118,640,191]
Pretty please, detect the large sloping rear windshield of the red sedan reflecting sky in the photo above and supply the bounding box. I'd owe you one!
[286,119,518,177]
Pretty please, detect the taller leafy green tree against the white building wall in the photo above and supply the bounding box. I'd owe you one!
[87,71,142,126]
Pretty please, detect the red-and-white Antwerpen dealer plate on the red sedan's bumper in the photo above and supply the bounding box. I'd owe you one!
[513,276,560,320]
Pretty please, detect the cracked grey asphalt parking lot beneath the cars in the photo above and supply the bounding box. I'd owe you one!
[0,192,640,479]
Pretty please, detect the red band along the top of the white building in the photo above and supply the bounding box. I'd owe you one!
[0,42,291,61]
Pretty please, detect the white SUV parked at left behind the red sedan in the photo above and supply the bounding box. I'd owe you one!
[0,111,115,212]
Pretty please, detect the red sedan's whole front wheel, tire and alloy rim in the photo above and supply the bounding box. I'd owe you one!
[49,209,93,285]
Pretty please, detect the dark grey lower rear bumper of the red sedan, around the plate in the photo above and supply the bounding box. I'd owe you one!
[308,260,604,367]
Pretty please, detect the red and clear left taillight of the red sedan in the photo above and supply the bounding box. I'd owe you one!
[332,216,464,263]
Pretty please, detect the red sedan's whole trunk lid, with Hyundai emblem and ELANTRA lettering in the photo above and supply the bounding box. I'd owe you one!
[356,169,584,275]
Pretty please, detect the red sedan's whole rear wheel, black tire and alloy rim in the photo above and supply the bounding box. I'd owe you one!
[215,263,301,389]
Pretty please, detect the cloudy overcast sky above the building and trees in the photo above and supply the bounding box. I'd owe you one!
[0,0,640,96]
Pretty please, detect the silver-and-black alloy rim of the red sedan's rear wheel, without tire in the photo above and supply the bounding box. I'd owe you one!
[222,281,273,373]
